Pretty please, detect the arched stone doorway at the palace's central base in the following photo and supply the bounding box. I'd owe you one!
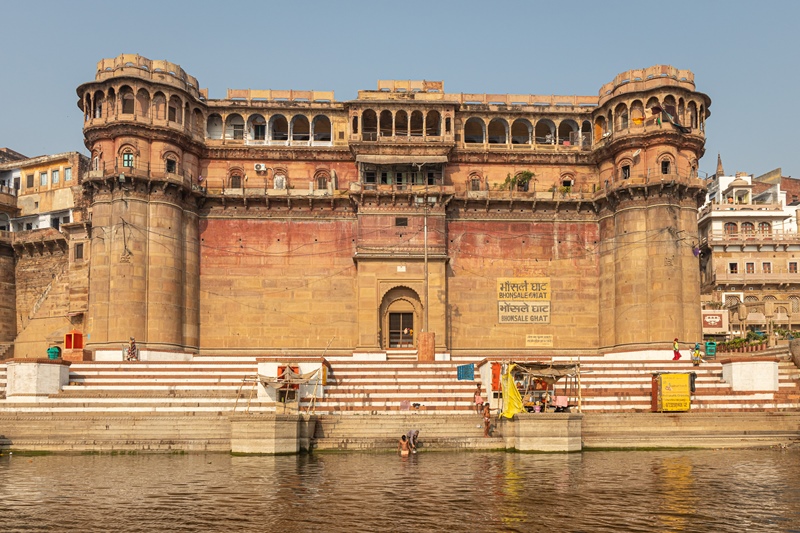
[379,286,422,350]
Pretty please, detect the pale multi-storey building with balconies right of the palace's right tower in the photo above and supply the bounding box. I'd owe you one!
[698,159,800,336]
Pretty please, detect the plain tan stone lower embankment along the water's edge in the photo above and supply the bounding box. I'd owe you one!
[0,412,800,453]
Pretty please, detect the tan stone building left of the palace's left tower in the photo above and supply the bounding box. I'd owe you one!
[0,149,89,357]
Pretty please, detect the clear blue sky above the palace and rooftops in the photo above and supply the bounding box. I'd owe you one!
[0,0,800,178]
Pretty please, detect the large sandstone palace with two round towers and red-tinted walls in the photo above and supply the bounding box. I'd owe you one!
[57,55,710,358]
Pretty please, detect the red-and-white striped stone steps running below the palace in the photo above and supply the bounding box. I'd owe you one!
[0,349,800,416]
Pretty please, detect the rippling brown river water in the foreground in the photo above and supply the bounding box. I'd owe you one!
[0,449,800,533]
